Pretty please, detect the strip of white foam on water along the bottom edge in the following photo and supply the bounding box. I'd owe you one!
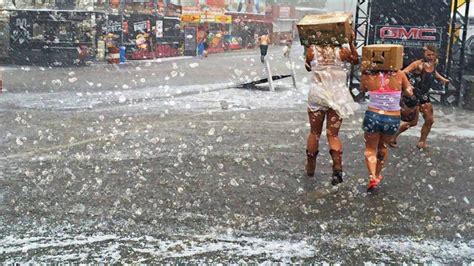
[0,234,474,263]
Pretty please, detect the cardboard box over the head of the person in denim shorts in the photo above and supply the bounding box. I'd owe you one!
[361,44,403,71]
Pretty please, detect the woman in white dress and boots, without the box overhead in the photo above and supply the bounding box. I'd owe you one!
[300,27,359,185]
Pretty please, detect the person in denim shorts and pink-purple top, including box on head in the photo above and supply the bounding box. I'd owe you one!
[360,45,416,193]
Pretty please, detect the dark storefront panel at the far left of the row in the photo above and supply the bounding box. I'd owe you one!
[8,10,96,65]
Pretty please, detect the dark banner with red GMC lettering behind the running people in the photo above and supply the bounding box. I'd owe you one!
[369,0,451,71]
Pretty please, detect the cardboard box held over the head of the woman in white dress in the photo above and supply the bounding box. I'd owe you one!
[296,13,352,46]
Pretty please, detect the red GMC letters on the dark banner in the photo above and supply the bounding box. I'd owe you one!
[379,26,438,41]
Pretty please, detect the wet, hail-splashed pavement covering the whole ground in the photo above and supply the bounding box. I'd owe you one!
[0,46,474,264]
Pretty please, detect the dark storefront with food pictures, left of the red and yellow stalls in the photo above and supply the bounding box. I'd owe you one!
[98,0,184,60]
